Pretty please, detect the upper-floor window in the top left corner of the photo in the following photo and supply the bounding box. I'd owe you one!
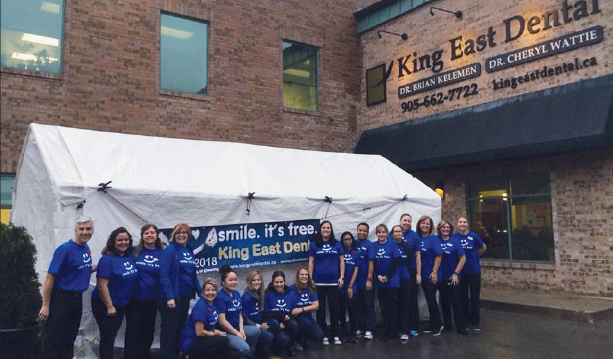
[0,0,64,74]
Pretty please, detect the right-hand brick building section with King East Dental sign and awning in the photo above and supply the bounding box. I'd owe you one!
[356,0,613,297]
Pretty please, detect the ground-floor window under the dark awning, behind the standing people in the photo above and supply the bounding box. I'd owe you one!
[467,173,554,262]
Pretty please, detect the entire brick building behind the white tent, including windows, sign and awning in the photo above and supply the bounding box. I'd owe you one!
[0,0,613,297]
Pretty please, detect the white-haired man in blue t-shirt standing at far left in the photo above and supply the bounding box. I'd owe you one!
[38,216,96,359]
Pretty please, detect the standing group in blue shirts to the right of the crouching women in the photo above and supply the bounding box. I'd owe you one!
[308,214,486,345]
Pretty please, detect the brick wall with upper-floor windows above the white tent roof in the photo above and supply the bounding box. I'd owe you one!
[1,0,373,172]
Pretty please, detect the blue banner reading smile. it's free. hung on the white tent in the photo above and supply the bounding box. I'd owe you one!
[159,219,319,274]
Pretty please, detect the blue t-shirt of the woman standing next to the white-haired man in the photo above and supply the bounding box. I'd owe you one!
[92,254,138,306]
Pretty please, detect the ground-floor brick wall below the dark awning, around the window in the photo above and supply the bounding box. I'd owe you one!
[414,149,613,297]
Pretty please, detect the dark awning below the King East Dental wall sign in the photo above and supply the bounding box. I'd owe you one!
[354,75,613,170]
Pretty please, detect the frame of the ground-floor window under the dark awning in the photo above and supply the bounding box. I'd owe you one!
[465,171,556,264]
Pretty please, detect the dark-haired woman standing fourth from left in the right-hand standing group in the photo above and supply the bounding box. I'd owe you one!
[373,224,400,340]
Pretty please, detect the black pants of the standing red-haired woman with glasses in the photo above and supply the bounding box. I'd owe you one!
[157,295,191,359]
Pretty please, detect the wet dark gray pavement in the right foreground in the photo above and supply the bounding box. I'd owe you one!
[294,310,613,359]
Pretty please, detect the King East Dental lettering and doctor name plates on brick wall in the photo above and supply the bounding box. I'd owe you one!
[366,0,603,108]
